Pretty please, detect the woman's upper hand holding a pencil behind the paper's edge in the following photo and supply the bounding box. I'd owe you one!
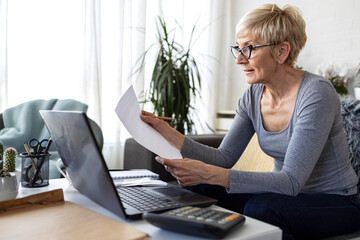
[140,110,185,151]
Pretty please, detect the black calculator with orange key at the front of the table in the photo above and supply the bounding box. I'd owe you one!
[143,206,245,238]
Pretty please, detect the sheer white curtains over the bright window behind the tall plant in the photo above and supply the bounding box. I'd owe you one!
[0,0,236,168]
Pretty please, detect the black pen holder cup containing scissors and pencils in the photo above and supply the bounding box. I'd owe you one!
[20,153,51,188]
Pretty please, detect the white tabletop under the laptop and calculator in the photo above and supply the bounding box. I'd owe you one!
[17,178,282,240]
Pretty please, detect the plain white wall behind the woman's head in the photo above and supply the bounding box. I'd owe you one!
[217,0,360,110]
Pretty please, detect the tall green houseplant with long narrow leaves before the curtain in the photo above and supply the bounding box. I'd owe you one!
[139,17,201,133]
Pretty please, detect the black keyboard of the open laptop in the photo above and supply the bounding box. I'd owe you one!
[116,187,182,211]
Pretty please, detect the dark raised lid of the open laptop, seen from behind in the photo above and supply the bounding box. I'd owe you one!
[40,110,126,218]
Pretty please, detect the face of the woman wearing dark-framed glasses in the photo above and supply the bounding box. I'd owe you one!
[236,36,278,84]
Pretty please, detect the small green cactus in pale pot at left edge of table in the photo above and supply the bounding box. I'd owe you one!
[0,141,19,201]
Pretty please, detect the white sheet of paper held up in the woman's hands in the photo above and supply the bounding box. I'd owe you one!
[115,86,183,159]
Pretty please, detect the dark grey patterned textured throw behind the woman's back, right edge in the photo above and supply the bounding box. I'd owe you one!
[341,98,360,184]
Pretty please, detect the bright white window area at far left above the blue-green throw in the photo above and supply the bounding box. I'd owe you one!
[8,0,84,106]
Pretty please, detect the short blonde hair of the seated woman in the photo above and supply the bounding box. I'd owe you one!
[236,4,307,66]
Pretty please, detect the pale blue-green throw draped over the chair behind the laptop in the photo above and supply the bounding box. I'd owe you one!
[0,99,88,155]
